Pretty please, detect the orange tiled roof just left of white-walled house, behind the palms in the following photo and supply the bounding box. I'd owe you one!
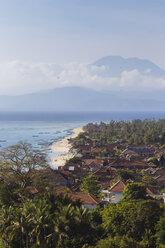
[68,192,100,210]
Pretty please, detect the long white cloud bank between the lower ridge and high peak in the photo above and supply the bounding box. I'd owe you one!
[0,61,165,95]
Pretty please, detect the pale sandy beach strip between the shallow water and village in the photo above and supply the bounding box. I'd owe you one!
[51,127,83,167]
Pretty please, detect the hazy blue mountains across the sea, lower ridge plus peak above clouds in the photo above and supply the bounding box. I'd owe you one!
[0,56,165,112]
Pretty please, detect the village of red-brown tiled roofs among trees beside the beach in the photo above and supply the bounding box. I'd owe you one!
[43,120,165,210]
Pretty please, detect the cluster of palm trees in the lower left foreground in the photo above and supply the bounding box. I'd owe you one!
[0,193,96,248]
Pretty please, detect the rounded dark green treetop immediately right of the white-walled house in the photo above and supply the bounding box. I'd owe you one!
[122,183,146,201]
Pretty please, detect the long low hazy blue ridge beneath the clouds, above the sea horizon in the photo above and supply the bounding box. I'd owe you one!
[0,87,165,112]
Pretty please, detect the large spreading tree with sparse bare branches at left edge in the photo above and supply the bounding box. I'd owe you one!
[0,142,48,204]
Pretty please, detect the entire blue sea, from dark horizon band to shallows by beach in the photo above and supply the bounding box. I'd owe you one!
[0,112,165,166]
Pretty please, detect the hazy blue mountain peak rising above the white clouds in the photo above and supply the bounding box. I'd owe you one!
[93,56,165,77]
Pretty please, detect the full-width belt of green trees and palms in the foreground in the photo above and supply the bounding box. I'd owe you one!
[0,179,165,248]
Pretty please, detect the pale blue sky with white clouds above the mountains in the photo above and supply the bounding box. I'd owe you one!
[0,0,165,94]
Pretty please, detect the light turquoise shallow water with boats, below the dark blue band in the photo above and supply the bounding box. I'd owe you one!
[0,121,83,167]
